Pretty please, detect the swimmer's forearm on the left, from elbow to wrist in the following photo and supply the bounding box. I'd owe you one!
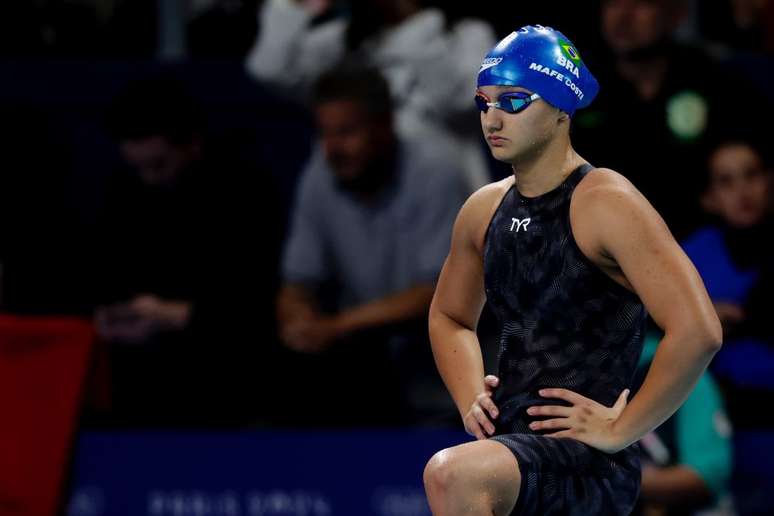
[429,309,485,417]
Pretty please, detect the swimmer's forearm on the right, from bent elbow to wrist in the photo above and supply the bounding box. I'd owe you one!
[614,332,720,448]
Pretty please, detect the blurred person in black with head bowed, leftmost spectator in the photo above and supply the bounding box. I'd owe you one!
[95,73,280,426]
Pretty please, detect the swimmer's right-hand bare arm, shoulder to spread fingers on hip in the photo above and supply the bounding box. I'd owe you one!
[530,171,722,452]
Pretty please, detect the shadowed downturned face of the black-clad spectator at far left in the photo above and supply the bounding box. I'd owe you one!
[121,135,198,186]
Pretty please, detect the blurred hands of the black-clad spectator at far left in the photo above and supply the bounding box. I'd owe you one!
[95,294,192,344]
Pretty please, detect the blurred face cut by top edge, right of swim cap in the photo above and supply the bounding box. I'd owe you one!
[602,0,684,56]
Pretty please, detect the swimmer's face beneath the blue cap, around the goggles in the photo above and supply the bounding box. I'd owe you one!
[478,86,567,164]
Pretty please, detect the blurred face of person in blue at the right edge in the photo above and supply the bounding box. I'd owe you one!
[703,143,770,228]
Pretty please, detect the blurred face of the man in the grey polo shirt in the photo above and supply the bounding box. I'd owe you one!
[315,99,393,184]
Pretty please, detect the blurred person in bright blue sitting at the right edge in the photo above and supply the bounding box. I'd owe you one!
[683,140,774,429]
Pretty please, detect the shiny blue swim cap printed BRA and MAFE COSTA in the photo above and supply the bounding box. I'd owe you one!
[478,25,599,115]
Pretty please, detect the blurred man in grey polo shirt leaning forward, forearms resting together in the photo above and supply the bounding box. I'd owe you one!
[278,64,469,426]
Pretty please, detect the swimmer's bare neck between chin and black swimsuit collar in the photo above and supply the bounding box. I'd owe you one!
[511,135,586,197]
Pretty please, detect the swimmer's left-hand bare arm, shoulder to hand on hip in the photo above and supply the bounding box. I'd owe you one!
[429,183,504,439]
